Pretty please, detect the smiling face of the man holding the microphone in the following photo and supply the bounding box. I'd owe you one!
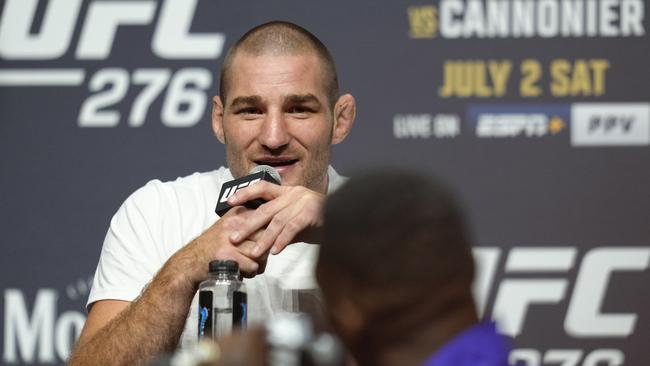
[215,53,334,192]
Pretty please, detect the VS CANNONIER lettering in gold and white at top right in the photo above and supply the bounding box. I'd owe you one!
[408,0,646,39]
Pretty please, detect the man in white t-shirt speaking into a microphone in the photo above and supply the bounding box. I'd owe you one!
[70,22,356,365]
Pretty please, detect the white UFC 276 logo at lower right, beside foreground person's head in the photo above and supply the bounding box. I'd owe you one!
[473,246,650,366]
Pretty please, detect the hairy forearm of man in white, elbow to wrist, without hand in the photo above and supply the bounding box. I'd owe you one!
[69,243,201,366]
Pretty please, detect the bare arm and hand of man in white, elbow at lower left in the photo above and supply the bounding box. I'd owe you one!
[69,207,259,366]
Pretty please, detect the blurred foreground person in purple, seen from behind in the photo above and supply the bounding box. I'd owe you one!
[316,171,508,366]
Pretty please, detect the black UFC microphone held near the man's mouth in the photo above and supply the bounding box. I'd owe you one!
[214,165,282,216]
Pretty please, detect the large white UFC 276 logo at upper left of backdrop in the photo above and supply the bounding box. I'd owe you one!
[0,0,226,128]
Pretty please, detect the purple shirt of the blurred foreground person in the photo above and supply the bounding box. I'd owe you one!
[422,323,510,366]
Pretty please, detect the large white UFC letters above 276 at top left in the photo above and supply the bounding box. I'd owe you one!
[0,0,225,60]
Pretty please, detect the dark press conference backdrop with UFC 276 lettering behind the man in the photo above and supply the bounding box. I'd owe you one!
[0,0,650,366]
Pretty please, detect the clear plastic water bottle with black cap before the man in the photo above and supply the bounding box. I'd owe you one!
[198,260,248,340]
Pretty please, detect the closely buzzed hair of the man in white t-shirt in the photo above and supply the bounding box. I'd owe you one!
[219,21,339,108]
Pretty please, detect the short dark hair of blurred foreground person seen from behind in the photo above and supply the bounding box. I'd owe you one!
[318,170,474,294]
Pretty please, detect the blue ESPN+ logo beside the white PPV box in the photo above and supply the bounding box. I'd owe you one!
[468,105,570,138]
